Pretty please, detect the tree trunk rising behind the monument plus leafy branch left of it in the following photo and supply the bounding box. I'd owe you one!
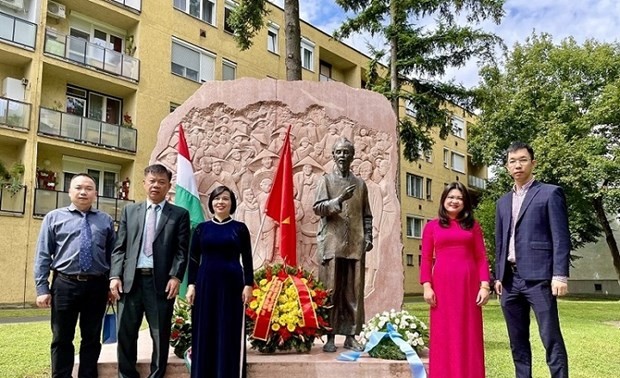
[230,0,301,81]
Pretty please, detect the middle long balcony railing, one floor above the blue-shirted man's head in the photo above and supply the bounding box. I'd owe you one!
[39,107,138,152]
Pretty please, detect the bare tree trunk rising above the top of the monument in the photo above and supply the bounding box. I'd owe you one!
[284,0,301,81]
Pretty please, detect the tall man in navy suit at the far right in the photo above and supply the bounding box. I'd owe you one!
[495,142,571,378]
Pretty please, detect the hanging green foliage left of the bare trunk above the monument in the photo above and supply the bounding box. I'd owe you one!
[229,0,269,51]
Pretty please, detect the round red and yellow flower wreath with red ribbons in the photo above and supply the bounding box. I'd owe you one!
[245,264,331,353]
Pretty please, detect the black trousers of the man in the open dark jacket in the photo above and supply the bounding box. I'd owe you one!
[117,272,174,378]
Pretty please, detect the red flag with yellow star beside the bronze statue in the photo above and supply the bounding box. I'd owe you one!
[265,125,297,266]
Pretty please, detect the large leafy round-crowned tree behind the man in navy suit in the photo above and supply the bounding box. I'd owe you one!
[469,34,620,282]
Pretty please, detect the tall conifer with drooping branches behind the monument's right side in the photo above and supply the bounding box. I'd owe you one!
[335,0,504,160]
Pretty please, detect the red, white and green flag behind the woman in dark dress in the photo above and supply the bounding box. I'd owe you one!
[174,124,205,297]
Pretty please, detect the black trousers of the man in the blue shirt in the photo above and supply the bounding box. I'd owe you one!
[51,276,109,378]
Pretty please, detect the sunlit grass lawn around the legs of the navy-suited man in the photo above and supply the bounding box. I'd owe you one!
[406,298,620,378]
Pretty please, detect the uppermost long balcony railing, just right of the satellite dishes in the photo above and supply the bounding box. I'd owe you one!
[44,29,140,81]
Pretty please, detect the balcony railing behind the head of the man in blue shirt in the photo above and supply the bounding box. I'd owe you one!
[32,189,134,222]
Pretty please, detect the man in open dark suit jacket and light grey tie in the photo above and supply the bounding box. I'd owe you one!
[110,164,190,378]
